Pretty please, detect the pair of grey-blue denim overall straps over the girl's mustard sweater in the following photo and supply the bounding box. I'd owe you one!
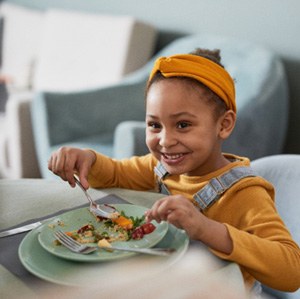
[154,163,255,211]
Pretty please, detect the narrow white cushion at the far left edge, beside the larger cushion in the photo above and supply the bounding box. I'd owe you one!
[0,2,44,89]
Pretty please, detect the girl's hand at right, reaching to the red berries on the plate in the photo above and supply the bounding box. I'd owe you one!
[146,195,208,240]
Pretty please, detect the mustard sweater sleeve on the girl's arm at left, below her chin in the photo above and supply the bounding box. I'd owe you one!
[88,152,156,191]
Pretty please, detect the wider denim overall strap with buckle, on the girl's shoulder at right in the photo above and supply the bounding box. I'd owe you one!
[194,166,255,211]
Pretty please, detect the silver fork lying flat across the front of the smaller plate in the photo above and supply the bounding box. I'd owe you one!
[54,230,176,256]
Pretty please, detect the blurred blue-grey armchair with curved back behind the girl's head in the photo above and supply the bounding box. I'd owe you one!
[32,34,288,177]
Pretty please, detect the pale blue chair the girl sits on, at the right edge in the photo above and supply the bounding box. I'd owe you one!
[251,154,300,299]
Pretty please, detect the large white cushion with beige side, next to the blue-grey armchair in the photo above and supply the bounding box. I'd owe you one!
[33,10,156,91]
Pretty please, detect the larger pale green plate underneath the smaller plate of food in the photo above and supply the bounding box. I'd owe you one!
[18,220,189,286]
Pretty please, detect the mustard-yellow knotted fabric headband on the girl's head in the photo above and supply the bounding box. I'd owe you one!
[149,54,236,112]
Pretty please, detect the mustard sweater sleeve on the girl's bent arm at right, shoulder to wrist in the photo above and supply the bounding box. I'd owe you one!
[209,180,300,292]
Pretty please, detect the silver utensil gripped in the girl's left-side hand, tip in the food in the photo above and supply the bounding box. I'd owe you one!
[74,174,120,219]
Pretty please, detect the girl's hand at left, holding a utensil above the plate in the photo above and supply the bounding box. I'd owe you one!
[48,147,96,189]
